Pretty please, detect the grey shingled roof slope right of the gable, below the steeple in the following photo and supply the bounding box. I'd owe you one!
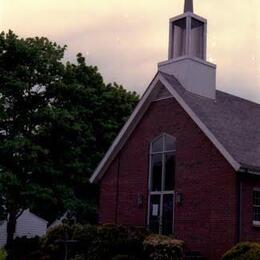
[160,72,260,171]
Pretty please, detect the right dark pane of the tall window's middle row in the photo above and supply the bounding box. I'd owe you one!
[164,153,175,191]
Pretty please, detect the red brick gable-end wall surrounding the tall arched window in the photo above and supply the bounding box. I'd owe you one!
[97,98,236,259]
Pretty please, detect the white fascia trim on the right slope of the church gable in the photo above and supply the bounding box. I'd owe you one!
[159,75,241,171]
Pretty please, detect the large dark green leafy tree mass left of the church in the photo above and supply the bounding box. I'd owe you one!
[0,31,138,249]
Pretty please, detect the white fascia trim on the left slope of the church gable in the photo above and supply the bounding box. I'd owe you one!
[89,73,159,183]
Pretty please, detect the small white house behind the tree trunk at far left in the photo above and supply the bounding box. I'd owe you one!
[0,209,48,247]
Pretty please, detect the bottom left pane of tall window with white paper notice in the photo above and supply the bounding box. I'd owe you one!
[149,195,160,233]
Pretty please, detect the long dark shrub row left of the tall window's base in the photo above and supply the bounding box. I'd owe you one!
[42,224,148,260]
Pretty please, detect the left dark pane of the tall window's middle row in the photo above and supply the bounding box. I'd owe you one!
[151,154,162,191]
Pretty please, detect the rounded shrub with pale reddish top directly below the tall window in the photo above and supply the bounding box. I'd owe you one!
[143,234,184,260]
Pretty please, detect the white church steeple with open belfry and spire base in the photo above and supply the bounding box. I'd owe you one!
[158,0,216,98]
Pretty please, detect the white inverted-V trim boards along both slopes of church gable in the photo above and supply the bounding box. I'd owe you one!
[90,72,241,183]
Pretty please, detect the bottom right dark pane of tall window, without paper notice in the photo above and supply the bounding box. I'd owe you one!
[162,194,173,235]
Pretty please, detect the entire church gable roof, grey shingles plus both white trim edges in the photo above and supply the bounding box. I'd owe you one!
[90,72,260,182]
